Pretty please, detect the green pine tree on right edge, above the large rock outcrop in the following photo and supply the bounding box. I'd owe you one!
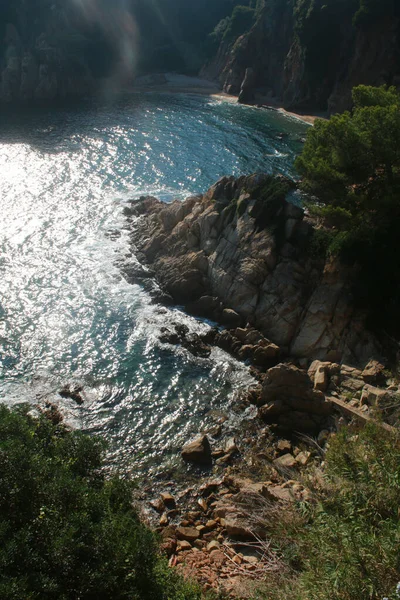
[296,86,400,335]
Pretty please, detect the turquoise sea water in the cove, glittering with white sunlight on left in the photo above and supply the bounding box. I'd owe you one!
[0,94,307,474]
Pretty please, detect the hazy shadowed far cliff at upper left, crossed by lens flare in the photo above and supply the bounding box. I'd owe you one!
[0,0,244,104]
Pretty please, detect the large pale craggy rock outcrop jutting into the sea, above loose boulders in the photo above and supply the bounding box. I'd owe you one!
[130,175,376,363]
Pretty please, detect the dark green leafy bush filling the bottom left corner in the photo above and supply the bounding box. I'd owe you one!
[0,406,200,600]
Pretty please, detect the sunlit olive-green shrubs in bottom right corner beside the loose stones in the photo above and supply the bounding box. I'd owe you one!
[260,426,400,600]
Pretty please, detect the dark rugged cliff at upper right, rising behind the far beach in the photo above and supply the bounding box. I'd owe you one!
[202,0,400,113]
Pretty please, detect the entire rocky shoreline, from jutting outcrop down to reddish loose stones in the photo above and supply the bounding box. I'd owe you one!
[125,175,399,598]
